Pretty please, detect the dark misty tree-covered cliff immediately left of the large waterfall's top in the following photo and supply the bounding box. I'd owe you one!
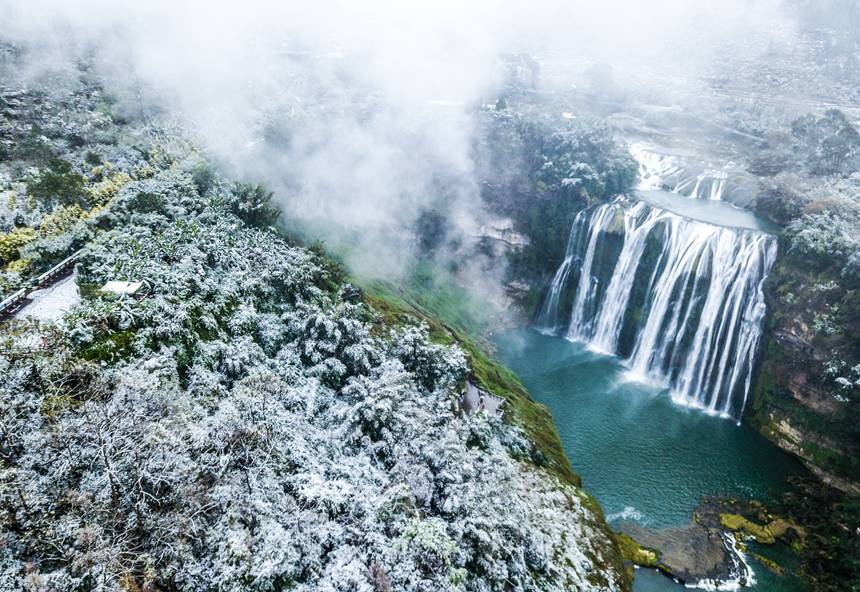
[476,109,638,285]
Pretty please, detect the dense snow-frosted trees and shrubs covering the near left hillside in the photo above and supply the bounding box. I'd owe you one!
[0,172,620,592]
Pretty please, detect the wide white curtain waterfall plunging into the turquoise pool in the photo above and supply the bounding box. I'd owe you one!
[536,198,776,419]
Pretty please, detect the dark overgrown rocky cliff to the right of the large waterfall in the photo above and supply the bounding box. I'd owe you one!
[747,251,860,494]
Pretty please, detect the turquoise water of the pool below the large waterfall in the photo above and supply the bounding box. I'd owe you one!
[496,330,804,592]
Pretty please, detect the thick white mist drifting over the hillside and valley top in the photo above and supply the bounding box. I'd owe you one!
[0,0,808,277]
